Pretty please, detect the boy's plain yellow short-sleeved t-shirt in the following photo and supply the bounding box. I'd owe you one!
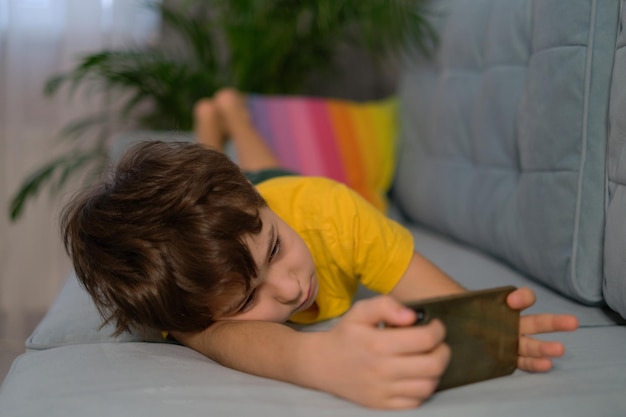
[257,176,413,324]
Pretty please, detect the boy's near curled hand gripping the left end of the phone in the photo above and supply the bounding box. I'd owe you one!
[303,296,450,409]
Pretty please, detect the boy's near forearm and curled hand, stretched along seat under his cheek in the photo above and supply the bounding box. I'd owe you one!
[172,297,449,409]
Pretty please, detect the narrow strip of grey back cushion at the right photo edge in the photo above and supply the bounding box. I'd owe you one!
[604,1,626,318]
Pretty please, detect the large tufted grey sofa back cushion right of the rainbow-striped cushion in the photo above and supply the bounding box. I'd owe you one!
[396,0,626,303]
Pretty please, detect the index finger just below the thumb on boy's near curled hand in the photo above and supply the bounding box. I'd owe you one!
[373,320,446,356]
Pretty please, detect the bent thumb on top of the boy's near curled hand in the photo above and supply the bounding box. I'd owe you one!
[344,295,417,327]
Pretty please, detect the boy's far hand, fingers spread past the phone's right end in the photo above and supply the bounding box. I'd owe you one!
[507,288,578,372]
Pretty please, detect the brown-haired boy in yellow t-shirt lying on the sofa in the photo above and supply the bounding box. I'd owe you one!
[62,89,578,409]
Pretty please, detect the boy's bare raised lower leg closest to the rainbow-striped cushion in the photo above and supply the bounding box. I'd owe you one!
[215,88,281,171]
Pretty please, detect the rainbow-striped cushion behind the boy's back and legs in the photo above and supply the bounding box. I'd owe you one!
[248,95,397,211]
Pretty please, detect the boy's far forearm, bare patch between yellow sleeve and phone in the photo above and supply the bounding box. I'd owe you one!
[390,252,466,302]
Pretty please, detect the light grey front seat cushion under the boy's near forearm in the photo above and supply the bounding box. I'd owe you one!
[0,326,626,417]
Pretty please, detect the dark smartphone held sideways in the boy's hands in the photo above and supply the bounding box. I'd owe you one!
[406,286,520,391]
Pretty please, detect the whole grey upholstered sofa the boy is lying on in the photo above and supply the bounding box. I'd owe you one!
[0,0,626,417]
